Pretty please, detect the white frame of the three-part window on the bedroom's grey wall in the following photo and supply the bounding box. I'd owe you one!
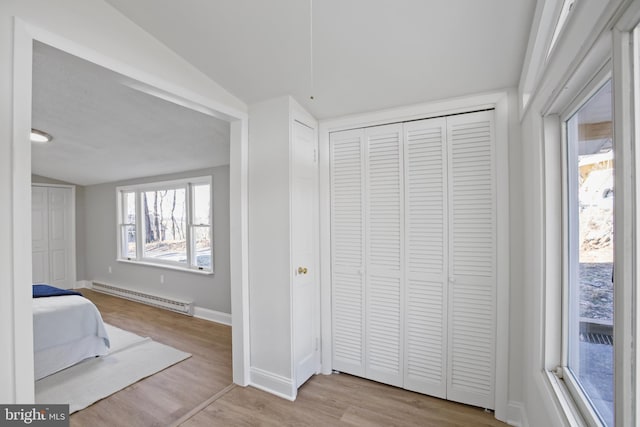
[116,176,214,274]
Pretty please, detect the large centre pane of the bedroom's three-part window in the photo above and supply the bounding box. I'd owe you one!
[142,188,187,264]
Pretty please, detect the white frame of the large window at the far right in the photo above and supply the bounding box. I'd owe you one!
[543,2,640,426]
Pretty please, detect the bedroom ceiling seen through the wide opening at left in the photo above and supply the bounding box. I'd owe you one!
[31,42,230,185]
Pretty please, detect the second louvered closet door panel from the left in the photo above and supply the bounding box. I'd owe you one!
[365,124,404,386]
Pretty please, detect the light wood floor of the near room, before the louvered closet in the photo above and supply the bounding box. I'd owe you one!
[182,374,506,427]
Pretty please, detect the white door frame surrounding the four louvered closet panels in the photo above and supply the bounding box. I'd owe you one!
[318,90,510,421]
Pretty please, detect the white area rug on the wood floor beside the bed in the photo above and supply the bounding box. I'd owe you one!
[36,324,191,413]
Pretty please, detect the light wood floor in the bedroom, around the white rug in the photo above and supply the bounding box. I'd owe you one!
[70,289,232,427]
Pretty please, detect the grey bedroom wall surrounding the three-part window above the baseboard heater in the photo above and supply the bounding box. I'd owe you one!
[84,166,231,313]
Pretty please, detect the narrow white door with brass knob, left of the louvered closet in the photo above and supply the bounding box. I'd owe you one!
[291,121,320,387]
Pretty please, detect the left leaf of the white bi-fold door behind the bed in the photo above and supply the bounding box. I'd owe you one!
[31,187,49,283]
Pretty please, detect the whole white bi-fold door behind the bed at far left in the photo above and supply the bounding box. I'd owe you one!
[31,185,75,289]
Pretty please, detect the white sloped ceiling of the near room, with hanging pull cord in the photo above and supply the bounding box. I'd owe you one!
[106,0,536,119]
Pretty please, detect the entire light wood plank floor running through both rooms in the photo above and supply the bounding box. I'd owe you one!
[71,290,506,427]
